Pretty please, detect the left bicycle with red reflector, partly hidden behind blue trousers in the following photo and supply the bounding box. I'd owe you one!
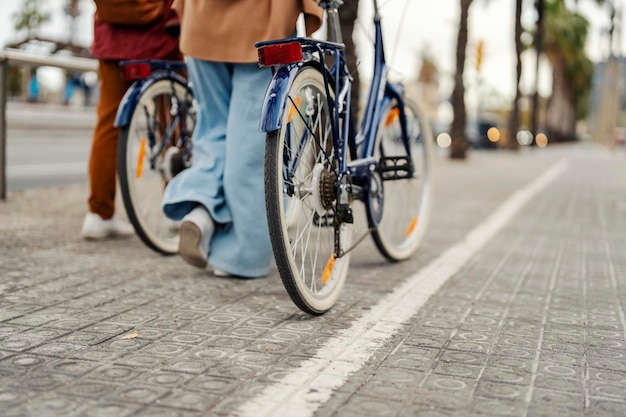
[115,60,196,254]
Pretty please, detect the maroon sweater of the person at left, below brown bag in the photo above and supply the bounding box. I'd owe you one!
[91,0,178,60]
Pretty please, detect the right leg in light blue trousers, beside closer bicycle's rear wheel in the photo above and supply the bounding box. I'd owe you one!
[209,63,273,277]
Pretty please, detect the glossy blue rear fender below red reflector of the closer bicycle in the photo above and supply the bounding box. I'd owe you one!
[259,64,300,132]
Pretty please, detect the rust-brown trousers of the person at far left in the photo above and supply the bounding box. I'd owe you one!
[87,51,183,219]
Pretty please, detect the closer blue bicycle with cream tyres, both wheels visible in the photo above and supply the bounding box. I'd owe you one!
[256,0,433,315]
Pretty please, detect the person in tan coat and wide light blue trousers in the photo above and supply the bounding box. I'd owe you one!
[163,0,322,278]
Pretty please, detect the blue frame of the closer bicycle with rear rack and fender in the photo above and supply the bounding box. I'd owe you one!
[256,2,413,227]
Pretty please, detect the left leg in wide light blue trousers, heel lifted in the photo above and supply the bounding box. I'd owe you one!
[163,58,232,223]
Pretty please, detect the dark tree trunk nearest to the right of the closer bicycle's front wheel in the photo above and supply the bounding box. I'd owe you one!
[450,0,473,159]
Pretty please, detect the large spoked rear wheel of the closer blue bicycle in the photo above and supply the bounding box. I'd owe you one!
[265,66,352,315]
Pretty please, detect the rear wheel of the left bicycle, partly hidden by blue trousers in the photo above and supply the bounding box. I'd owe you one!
[117,78,195,254]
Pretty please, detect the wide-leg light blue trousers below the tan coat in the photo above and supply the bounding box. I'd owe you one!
[163,57,273,277]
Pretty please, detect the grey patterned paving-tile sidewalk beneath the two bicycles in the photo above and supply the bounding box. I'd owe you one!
[0,145,626,417]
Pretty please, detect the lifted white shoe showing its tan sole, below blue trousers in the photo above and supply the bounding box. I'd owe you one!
[178,206,215,268]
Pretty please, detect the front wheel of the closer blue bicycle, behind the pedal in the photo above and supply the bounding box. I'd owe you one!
[367,100,433,261]
